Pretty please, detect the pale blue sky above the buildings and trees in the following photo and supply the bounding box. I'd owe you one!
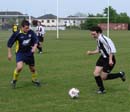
[0,0,130,17]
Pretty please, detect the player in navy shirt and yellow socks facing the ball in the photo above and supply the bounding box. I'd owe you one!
[7,20,40,88]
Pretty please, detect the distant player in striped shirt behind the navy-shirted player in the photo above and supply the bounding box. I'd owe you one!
[36,21,45,54]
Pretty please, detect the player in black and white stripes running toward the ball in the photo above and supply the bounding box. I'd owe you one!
[87,26,126,94]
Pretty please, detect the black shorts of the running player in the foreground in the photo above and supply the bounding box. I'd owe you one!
[96,56,116,73]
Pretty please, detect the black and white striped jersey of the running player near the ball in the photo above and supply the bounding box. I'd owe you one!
[97,34,116,58]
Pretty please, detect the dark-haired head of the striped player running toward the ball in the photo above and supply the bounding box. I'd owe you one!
[90,26,102,38]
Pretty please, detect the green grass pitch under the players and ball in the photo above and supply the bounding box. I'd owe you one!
[0,30,130,112]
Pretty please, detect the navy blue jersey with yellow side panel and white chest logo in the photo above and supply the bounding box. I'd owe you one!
[7,30,38,53]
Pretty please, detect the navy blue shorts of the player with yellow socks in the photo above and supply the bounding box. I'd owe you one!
[16,52,35,66]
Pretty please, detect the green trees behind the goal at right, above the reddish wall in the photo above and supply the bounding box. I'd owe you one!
[80,6,130,30]
